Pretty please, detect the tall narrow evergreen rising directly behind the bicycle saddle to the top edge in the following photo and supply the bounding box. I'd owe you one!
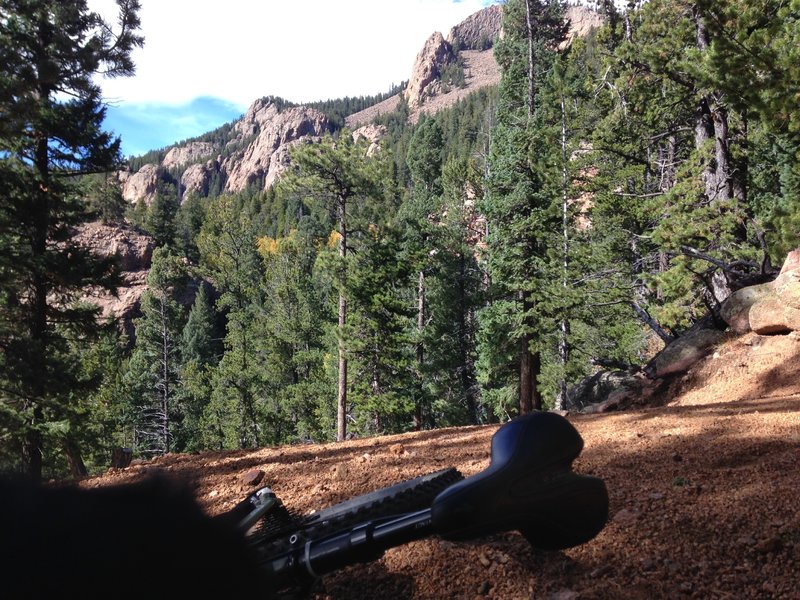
[482,0,566,413]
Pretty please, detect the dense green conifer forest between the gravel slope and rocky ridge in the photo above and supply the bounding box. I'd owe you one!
[0,0,800,477]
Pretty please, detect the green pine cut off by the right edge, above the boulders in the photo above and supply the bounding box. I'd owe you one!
[691,0,800,261]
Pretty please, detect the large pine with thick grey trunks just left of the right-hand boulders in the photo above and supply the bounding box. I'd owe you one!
[595,0,760,332]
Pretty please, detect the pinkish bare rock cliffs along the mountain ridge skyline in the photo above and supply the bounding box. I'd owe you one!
[118,5,601,205]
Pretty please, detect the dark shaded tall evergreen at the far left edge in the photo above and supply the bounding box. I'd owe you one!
[0,0,142,478]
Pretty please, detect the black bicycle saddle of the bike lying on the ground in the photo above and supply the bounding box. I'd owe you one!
[431,412,608,550]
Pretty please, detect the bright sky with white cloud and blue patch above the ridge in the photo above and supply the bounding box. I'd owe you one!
[88,0,497,156]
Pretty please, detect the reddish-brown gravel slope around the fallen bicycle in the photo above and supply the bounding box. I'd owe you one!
[82,333,800,600]
